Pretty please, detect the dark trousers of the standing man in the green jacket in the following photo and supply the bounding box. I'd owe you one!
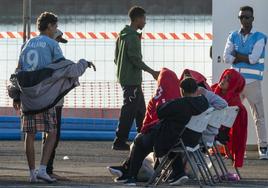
[116,85,146,141]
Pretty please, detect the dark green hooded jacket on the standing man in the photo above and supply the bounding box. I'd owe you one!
[114,25,151,86]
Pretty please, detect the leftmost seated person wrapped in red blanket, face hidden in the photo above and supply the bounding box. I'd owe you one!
[141,68,180,133]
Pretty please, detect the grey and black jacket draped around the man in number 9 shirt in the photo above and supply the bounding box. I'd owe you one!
[8,59,88,115]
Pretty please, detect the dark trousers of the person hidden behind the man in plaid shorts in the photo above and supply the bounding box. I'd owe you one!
[43,106,62,174]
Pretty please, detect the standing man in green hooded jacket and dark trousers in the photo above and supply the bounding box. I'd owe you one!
[112,6,159,150]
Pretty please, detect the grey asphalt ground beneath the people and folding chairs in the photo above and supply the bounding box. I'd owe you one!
[0,141,268,188]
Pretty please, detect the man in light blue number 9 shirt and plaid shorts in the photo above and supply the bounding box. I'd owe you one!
[13,12,64,183]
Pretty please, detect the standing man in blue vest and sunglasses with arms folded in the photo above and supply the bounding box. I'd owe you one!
[223,6,268,159]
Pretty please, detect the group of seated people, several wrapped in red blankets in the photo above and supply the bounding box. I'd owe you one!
[108,68,247,185]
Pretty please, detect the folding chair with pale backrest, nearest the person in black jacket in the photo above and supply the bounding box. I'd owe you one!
[147,108,213,187]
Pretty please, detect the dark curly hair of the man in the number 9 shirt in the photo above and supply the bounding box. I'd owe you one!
[36,12,58,31]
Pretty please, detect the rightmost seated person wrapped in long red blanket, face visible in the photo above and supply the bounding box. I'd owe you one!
[212,69,248,167]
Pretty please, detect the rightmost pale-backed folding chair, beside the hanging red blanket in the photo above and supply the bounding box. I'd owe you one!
[214,106,242,179]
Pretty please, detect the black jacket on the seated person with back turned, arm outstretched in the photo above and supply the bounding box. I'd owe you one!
[154,95,209,157]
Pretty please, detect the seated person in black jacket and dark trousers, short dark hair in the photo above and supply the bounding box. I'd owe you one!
[109,78,209,185]
